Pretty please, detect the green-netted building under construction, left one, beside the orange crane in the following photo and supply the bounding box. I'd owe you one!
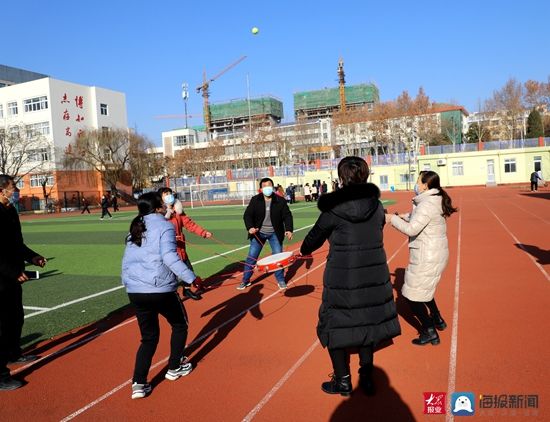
[210,96,283,134]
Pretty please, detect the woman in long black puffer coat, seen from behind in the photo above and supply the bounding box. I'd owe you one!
[300,157,401,396]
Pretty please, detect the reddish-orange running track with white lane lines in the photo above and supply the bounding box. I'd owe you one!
[0,187,550,421]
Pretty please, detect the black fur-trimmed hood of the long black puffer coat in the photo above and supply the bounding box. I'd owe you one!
[317,183,380,223]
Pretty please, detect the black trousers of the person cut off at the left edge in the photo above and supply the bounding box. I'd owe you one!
[0,282,25,375]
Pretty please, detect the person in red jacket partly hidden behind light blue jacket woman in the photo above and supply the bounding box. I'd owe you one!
[158,187,212,300]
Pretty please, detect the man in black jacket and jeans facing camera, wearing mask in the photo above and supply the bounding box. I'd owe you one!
[237,177,294,290]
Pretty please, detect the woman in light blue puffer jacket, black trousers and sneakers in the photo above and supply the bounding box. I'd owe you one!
[122,192,197,399]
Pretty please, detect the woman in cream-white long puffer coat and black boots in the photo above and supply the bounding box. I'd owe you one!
[386,171,457,346]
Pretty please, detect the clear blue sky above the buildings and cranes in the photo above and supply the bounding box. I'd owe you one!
[0,0,550,144]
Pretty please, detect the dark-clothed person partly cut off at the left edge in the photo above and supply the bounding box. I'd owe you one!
[0,174,46,391]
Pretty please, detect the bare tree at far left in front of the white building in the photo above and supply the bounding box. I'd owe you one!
[0,123,52,180]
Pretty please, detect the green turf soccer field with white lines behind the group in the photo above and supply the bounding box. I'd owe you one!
[22,202,394,347]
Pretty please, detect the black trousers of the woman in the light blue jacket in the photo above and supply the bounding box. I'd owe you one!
[128,292,188,384]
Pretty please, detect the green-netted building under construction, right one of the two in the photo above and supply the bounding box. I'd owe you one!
[294,84,380,120]
